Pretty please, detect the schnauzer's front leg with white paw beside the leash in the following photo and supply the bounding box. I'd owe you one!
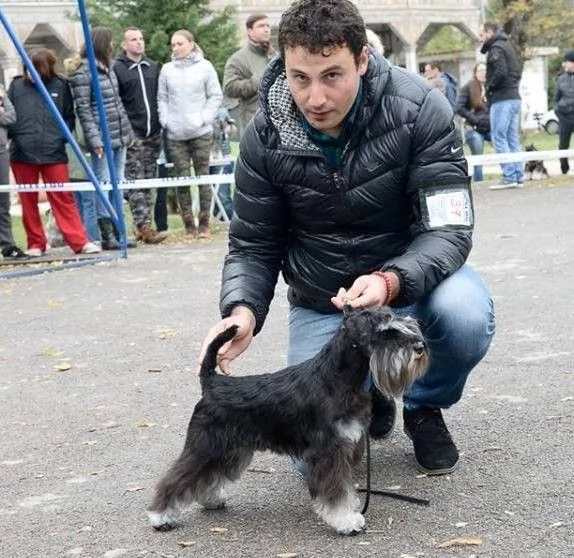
[304,440,365,535]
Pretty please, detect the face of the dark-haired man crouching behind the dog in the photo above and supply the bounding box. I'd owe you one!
[285,45,369,137]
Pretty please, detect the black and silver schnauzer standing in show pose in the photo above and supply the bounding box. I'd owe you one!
[147,307,429,535]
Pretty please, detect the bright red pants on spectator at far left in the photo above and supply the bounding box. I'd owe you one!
[10,161,89,252]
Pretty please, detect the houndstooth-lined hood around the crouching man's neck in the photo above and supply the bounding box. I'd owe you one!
[259,51,390,151]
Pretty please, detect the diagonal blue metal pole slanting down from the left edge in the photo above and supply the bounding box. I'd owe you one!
[0,6,125,247]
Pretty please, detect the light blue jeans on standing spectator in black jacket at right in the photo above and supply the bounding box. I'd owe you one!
[490,99,524,184]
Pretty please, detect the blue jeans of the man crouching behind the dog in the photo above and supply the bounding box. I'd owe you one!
[287,266,495,409]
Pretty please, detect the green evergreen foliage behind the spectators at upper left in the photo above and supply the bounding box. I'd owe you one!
[76,0,239,78]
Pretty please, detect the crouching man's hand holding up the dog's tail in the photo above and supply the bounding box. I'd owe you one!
[197,306,256,374]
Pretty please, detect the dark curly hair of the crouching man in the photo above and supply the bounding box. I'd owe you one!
[278,0,367,62]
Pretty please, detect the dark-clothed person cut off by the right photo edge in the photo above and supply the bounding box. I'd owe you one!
[554,50,574,174]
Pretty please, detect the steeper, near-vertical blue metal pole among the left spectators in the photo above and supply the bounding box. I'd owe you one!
[78,0,127,257]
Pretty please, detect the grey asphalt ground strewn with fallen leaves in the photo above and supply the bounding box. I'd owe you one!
[0,184,574,558]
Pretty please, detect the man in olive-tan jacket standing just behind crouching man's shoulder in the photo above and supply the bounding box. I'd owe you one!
[223,14,274,137]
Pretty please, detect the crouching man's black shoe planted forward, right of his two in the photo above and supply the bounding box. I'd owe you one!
[403,407,458,475]
